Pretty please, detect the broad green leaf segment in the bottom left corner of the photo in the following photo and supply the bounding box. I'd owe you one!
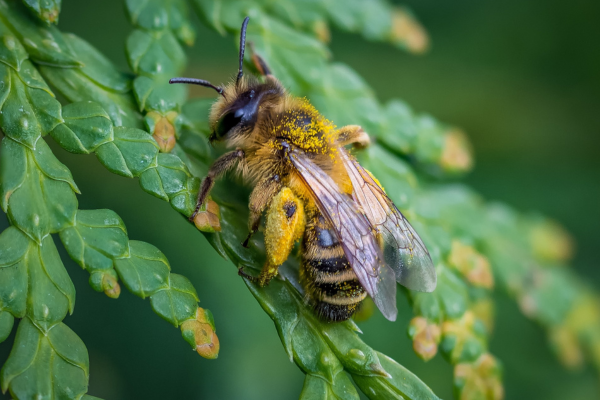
[1,318,89,399]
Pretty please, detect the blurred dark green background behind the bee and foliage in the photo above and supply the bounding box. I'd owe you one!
[0,0,600,399]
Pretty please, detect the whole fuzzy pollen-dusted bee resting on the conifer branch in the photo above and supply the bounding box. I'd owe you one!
[170,18,437,321]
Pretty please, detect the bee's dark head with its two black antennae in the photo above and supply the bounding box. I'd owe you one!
[169,17,283,142]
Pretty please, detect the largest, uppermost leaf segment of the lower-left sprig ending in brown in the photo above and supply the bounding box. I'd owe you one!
[60,210,129,272]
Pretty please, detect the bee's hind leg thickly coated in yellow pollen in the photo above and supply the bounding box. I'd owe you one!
[258,187,306,286]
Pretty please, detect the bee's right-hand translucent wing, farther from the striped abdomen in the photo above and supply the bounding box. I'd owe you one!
[340,148,437,292]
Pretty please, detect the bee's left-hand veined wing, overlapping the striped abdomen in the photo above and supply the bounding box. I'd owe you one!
[289,149,398,321]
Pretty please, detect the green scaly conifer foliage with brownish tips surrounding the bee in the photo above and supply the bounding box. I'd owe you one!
[0,0,600,399]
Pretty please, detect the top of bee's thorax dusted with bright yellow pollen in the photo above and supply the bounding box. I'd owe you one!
[275,99,336,155]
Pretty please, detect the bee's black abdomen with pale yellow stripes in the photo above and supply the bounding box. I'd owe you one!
[300,211,367,321]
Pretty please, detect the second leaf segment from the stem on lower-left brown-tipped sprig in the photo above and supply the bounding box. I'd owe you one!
[115,240,171,298]
